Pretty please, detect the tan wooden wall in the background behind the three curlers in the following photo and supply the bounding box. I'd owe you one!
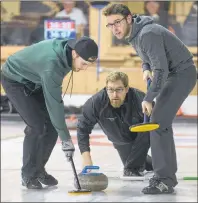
[1,2,198,95]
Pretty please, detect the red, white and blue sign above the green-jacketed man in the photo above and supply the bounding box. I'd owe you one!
[44,18,76,40]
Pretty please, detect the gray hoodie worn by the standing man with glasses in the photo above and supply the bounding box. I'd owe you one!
[127,16,193,102]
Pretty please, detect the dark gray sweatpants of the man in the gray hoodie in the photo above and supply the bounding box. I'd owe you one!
[150,65,197,187]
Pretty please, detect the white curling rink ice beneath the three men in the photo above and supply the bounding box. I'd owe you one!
[1,121,197,202]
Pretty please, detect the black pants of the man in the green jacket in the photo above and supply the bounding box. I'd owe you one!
[1,74,58,178]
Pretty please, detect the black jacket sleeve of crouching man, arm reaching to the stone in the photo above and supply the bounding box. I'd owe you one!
[77,97,98,154]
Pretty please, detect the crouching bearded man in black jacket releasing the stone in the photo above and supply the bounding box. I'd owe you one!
[77,72,152,176]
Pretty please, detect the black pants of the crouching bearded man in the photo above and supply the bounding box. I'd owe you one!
[113,132,152,170]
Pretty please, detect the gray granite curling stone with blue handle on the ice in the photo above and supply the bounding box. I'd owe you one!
[74,166,108,191]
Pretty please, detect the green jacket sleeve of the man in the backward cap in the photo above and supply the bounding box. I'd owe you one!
[42,71,71,141]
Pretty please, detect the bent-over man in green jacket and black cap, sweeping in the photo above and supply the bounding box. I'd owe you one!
[1,37,98,189]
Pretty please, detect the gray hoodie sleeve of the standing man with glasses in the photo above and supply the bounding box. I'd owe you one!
[141,32,169,102]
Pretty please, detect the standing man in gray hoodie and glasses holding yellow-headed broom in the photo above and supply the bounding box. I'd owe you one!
[104,4,196,194]
